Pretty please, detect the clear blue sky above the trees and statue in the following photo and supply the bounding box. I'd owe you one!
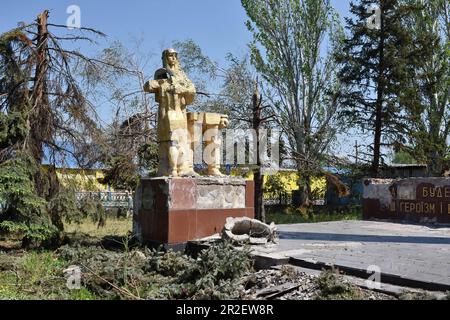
[0,0,362,160]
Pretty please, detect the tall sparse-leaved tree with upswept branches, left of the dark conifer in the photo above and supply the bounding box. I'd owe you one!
[242,0,342,205]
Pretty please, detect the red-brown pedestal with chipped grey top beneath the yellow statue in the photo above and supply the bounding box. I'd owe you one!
[133,177,254,246]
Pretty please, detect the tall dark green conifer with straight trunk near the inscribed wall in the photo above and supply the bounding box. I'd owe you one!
[337,0,414,177]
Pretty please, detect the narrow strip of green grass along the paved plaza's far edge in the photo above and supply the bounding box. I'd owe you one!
[266,209,362,224]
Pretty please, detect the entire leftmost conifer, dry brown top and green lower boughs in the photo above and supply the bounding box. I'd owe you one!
[0,11,109,243]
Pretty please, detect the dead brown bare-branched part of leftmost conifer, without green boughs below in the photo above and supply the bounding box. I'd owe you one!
[0,10,118,238]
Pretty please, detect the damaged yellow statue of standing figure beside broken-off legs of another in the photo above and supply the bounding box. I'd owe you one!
[144,49,228,177]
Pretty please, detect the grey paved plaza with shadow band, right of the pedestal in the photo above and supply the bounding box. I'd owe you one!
[254,221,450,290]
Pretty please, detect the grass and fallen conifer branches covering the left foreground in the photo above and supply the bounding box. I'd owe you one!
[0,242,252,299]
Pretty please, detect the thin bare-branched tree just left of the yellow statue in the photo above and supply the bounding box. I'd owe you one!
[85,41,157,190]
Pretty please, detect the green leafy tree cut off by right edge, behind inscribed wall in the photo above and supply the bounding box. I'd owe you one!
[401,0,450,176]
